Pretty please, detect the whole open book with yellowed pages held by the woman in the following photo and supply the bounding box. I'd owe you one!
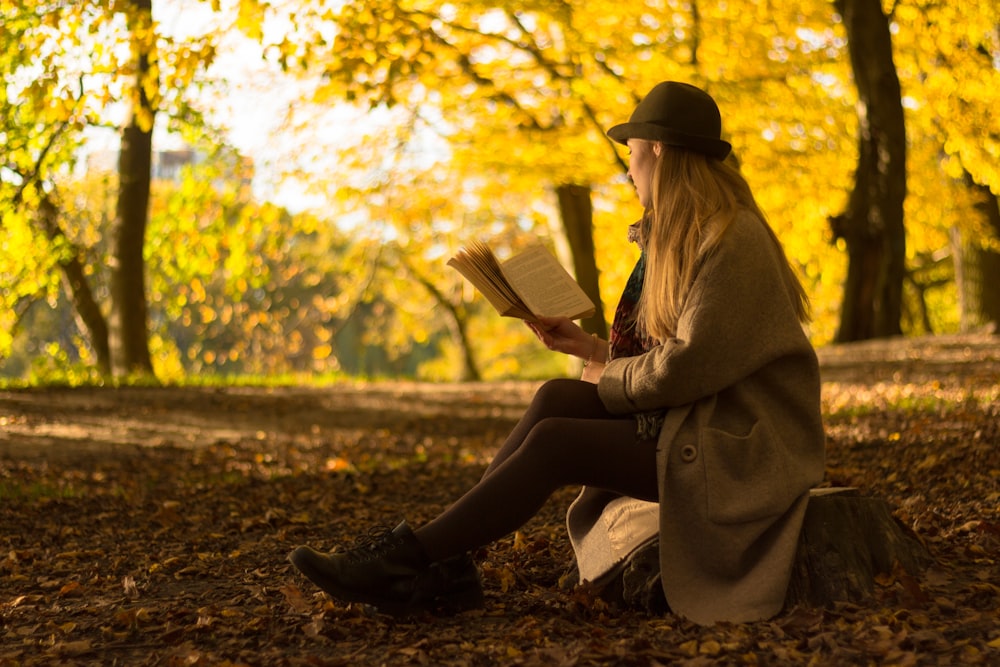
[448,241,596,320]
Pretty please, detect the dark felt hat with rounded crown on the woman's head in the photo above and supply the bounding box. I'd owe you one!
[608,81,732,160]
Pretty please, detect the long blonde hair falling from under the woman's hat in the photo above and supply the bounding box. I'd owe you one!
[638,144,809,342]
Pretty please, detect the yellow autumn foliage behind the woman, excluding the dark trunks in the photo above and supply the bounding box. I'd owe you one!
[0,0,1000,378]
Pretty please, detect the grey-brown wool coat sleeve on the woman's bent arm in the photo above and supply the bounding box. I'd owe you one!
[598,214,811,414]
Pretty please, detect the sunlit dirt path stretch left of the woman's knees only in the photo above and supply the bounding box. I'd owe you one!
[0,382,536,458]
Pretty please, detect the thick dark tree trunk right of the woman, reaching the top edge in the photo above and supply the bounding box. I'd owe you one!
[831,0,906,342]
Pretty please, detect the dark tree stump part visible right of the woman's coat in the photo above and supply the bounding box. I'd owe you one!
[785,487,933,607]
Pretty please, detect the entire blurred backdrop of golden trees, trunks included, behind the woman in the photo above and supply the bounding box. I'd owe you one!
[0,0,1000,382]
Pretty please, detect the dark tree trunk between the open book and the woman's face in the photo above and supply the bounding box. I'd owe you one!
[556,184,608,340]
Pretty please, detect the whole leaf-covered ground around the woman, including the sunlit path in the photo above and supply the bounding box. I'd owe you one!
[0,337,1000,665]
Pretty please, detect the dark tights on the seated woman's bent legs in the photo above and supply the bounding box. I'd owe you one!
[416,380,658,561]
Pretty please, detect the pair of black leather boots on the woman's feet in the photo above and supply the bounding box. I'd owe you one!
[288,521,483,614]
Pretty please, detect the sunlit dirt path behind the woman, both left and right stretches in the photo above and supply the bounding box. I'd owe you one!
[0,336,1000,458]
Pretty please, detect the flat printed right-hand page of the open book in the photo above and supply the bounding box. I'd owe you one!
[500,244,596,320]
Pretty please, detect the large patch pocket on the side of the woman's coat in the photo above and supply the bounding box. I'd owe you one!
[702,422,801,524]
